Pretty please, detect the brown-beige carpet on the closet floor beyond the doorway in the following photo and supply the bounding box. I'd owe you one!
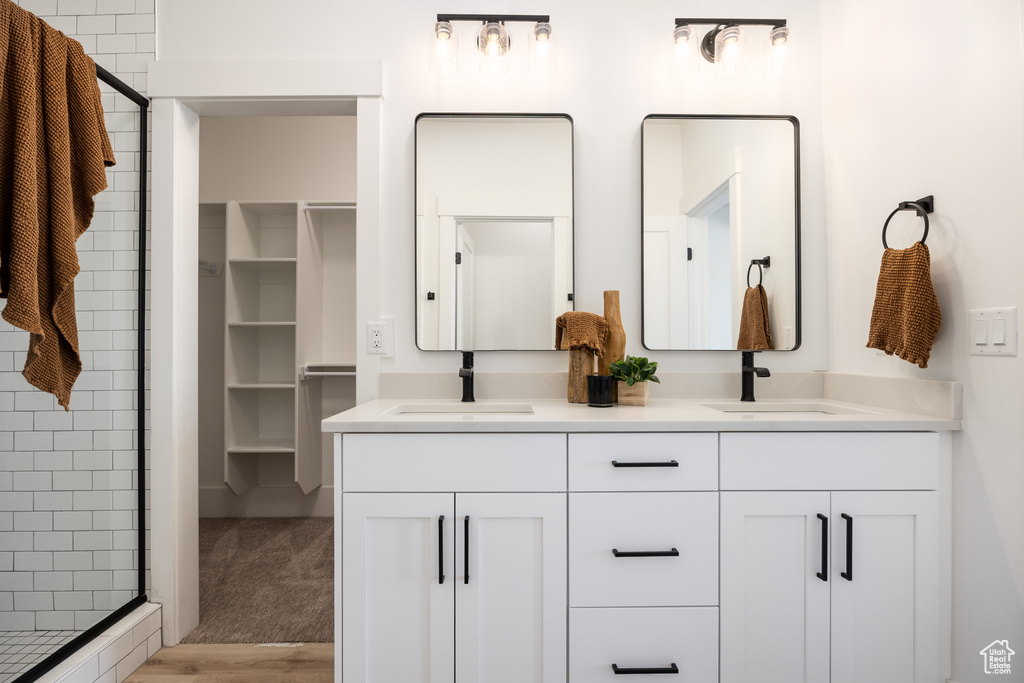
[181,517,334,643]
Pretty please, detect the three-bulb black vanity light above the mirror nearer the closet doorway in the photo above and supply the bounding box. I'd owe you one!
[430,14,557,77]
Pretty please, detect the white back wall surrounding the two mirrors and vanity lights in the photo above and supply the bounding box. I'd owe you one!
[158,0,827,372]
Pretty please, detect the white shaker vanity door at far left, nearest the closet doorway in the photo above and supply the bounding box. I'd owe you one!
[336,494,456,683]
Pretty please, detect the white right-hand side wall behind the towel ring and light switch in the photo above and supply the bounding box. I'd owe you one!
[822,0,1024,682]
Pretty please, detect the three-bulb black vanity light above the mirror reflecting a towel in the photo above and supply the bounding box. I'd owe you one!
[669,18,790,80]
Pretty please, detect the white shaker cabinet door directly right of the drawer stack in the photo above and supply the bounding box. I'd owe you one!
[720,492,831,683]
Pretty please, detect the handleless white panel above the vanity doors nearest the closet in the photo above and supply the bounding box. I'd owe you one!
[341,434,565,492]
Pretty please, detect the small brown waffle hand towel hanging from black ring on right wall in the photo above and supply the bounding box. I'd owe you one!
[867,242,942,368]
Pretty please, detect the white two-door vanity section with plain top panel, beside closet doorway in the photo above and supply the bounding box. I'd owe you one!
[341,434,566,683]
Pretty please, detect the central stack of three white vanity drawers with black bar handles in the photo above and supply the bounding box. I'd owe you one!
[568,433,718,683]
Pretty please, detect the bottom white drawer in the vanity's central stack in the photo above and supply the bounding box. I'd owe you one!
[569,607,718,683]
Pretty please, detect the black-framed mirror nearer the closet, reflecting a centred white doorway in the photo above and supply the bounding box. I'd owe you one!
[416,114,573,351]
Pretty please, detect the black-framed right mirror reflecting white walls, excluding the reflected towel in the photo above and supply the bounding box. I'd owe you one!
[641,115,800,350]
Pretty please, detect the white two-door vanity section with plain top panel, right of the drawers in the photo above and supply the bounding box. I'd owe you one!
[720,433,948,683]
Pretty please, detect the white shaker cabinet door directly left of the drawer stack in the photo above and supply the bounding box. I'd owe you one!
[456,494,566,683]
